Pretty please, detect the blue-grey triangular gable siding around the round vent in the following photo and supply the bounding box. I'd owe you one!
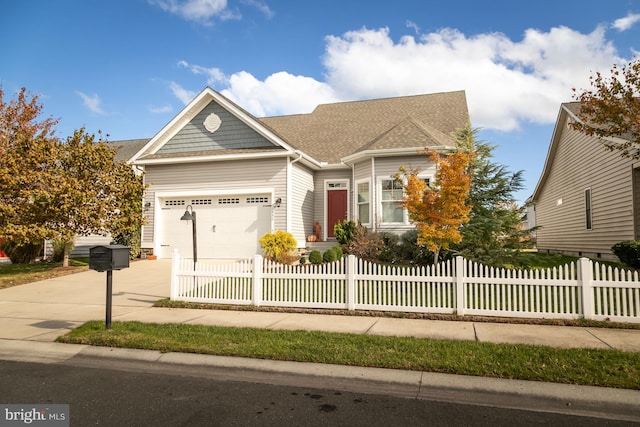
[157,101,273,154]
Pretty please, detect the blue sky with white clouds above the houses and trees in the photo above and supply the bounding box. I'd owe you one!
[0,0,640,202]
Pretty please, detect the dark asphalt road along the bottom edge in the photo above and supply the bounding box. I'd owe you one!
[0,361,640,427]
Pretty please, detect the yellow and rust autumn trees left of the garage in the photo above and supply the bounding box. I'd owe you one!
[0,89,144,265]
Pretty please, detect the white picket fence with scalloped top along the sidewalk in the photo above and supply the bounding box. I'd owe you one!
[171,252,640,323]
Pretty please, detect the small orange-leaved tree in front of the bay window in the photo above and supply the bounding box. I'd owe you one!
[395,150,473,264]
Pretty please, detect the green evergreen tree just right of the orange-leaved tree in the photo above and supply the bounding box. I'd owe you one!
[452,124,532,265]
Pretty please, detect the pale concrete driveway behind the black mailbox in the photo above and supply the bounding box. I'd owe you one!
[0,260,171,341]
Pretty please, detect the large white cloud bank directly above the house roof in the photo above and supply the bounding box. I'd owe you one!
[172,27,626,131]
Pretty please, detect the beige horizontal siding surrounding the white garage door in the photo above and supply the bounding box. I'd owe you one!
[142,158,288,256]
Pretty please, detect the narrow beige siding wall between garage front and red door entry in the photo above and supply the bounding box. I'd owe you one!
[291,163,314,247]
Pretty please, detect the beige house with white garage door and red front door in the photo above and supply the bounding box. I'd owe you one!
[130,87,469,259]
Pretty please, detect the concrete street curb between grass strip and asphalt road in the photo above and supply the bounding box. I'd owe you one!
[0,339,640,419]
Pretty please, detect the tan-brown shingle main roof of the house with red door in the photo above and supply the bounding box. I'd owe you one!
[259,91,469,163]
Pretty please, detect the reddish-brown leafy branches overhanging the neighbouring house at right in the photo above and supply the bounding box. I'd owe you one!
[571,59,640,159]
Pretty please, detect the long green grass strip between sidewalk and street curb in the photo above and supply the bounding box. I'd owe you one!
[57,321,640,389]
